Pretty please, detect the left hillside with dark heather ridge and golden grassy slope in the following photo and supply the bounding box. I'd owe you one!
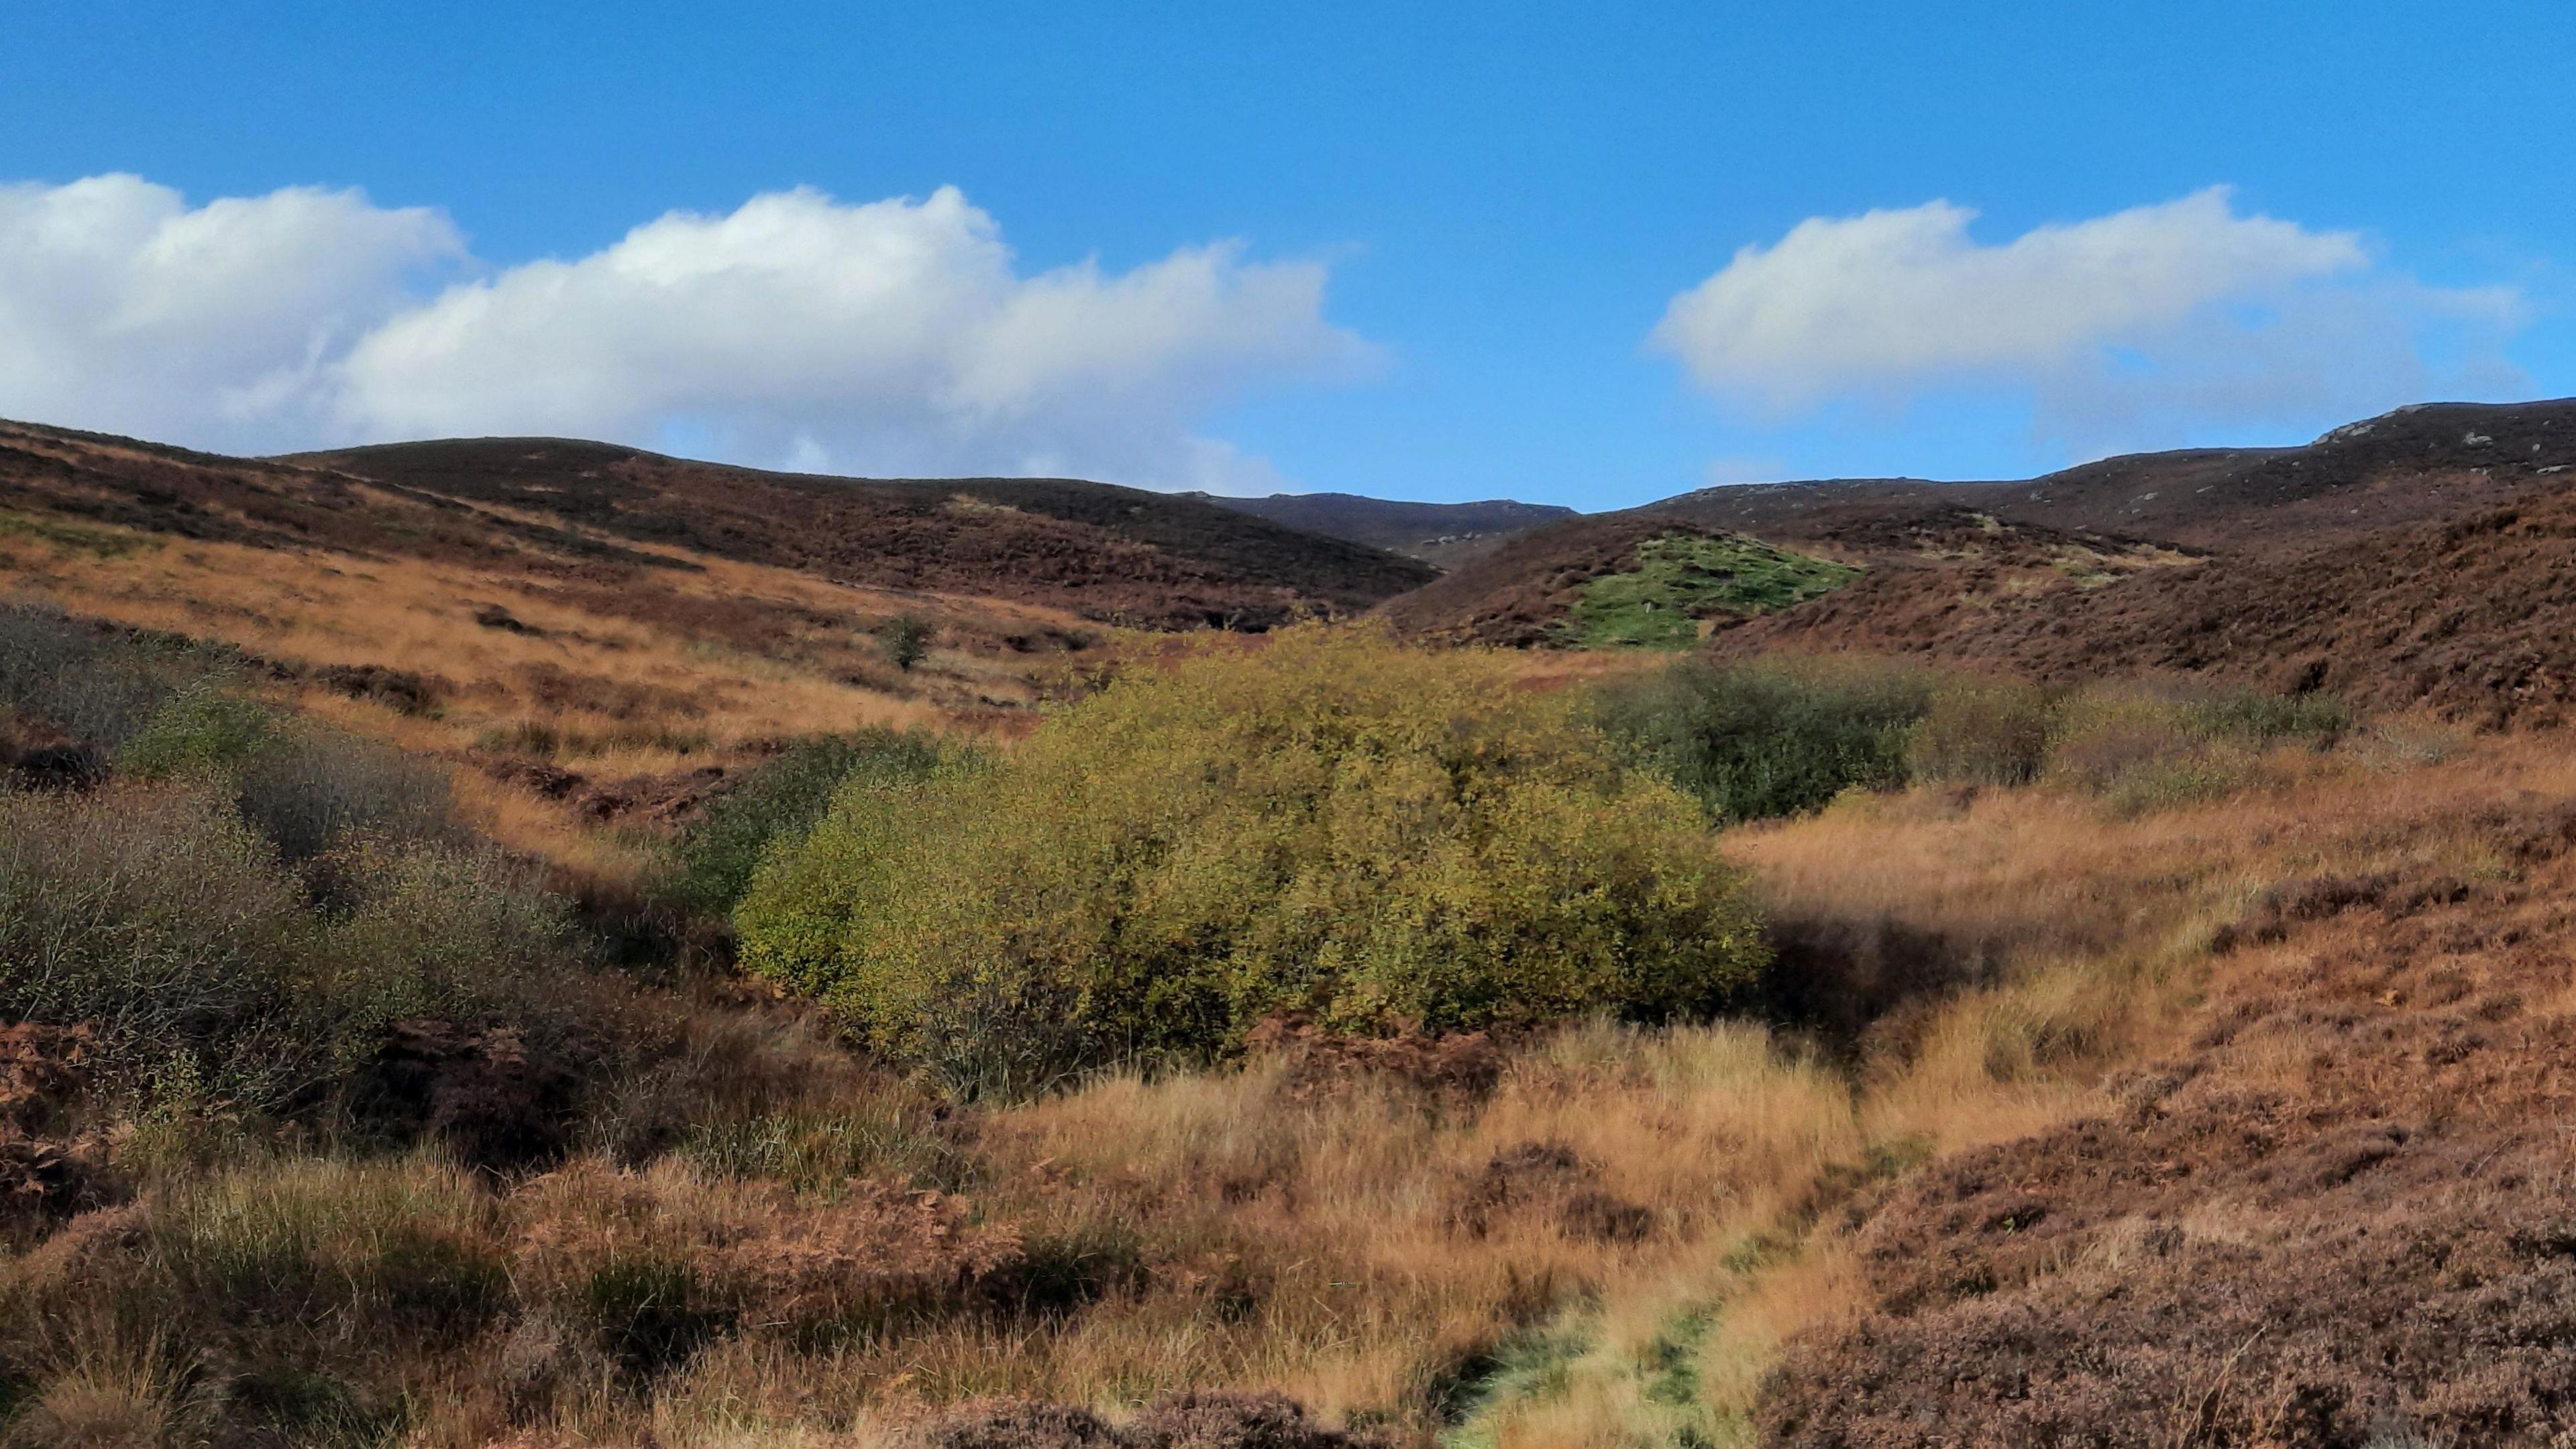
[0,423,1432,859]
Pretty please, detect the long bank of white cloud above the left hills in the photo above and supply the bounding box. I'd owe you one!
[0,178,1373,490]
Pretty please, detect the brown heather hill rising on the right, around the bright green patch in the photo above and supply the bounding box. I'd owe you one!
[1383,402,2576,719]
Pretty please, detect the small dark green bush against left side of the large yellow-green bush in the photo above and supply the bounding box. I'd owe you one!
[672,730,941,913]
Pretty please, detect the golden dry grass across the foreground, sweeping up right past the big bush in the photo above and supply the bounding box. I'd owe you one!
[10,716,2514,1446]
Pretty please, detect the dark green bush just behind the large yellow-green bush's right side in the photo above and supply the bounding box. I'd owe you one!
[1597,660,1932,820]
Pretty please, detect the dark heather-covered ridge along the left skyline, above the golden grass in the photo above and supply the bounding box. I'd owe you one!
[0,423,1432,629]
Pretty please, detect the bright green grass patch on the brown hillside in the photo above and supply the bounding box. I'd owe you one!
[1558,534,1860,650]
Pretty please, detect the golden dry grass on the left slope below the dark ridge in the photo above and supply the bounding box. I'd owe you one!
[0,526,1126,879]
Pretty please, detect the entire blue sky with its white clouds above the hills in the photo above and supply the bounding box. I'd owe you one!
[0,0,2576,508]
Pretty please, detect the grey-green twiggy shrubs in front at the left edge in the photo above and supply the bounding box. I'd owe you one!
[0,782,590,1109]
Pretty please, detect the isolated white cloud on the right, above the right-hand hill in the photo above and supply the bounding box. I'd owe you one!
[1651,189,2520,446]
